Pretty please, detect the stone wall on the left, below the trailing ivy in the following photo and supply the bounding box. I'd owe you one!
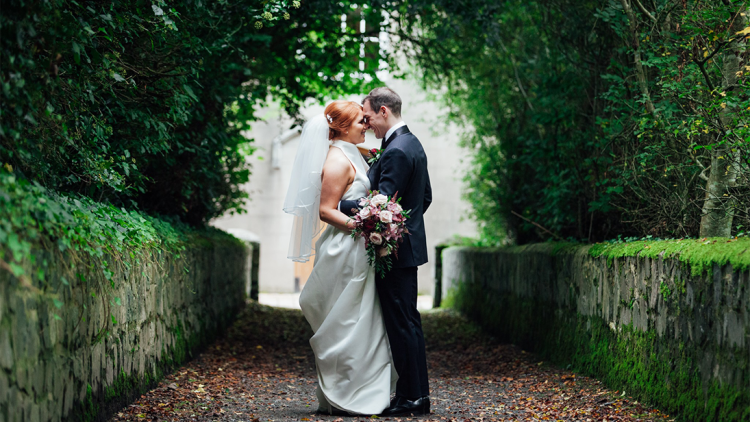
[0,234,247,422]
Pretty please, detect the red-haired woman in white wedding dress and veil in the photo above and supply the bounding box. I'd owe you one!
[284,101,398,415]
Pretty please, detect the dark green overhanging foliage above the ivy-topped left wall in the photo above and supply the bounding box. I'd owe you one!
[0,0,378,225]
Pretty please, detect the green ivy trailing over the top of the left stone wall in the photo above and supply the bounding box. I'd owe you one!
[0,172,200,308]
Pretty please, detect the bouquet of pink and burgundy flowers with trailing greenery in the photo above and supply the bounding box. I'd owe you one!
[352,191,409,276]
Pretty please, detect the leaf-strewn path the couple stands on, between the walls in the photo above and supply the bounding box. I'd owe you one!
[112,302,672,422]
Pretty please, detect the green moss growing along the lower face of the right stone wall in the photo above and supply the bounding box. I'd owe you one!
[453,283,750,421]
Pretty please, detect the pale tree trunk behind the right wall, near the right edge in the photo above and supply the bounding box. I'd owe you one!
[700,7,747,237]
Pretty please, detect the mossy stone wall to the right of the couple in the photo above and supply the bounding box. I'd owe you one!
[442,244,750,421]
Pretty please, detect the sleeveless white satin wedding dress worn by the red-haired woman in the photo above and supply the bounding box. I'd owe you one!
[299,141,398,415]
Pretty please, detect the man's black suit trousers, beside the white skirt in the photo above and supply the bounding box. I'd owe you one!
[375,267,430,400]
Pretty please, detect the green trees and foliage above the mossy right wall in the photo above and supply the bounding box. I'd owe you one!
[391,0,750,244]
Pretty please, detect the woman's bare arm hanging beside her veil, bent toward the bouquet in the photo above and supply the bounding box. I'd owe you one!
[320,148,355,232]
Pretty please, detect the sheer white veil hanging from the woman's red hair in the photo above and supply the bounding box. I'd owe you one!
[284,114,330,262]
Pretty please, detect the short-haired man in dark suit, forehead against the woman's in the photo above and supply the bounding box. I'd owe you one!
[339,87,432,416]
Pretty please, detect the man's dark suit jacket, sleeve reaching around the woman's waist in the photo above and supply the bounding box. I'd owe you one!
[340,126,432,268]
